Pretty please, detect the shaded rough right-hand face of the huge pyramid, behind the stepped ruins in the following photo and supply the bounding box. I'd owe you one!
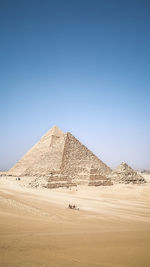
[61,133,110,185]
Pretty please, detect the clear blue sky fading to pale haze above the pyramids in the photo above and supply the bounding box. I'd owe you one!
[0,0,150,170]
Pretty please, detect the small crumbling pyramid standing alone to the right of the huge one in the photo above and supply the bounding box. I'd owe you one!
[109,162,146,184]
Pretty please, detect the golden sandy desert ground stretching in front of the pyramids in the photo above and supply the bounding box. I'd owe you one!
[0,175,150,267]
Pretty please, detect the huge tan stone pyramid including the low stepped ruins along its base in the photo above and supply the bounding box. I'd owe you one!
[9,126,112,188]
